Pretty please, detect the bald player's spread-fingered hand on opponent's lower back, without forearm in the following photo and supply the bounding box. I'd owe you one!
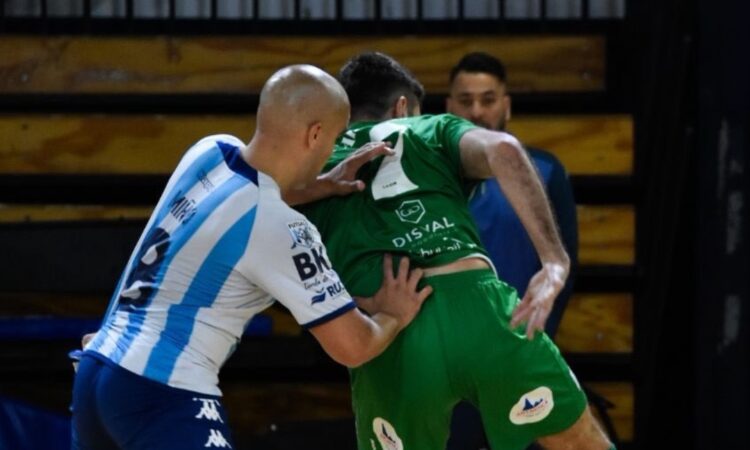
[356,255,432,329]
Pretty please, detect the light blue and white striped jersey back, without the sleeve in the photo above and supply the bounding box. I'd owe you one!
[87,135,272,394]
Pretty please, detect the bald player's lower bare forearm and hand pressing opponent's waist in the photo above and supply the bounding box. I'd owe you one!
[310,255,432,367]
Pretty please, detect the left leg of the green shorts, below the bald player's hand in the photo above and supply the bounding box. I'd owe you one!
[351,294,458,450]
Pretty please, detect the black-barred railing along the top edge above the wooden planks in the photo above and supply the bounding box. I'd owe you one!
[0,0,627,24]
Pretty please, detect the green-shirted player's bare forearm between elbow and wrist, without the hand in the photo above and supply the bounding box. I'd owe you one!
[487,140,570,271]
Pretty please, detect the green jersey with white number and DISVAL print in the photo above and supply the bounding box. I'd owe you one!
[302,114,489,296]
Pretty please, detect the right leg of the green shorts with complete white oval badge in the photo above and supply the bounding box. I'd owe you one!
[473,281,600,450]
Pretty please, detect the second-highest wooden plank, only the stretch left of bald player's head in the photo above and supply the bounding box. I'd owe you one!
[0,115,255,174]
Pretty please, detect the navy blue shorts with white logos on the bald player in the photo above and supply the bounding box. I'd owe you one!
[89,354,234,450]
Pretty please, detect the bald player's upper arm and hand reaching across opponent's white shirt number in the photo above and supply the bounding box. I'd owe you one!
[284,142,393,206]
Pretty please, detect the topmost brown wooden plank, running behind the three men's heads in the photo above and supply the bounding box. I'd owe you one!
[0,35,605,93]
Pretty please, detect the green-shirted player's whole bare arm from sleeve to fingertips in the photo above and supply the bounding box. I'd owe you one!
[459,128,570,339]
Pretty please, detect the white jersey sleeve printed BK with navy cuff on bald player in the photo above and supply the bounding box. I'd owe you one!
[245,201,355,328]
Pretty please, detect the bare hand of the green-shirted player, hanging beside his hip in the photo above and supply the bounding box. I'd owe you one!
[510,263,568,340]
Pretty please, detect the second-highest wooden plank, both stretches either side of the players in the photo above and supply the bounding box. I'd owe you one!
[0,114,632,175]
